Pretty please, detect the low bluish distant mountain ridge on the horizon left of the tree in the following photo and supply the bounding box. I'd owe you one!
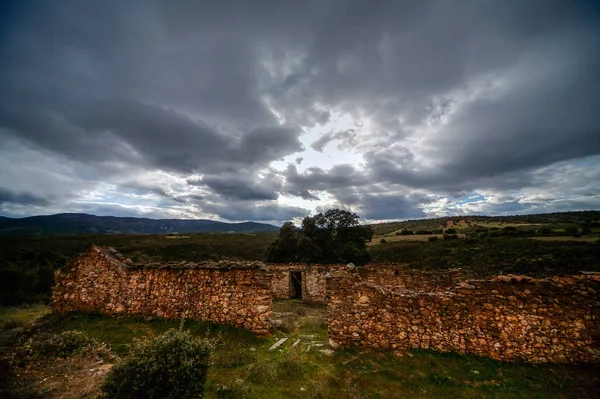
[0,213,279,235]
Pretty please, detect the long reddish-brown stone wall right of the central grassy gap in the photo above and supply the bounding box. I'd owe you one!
[327,269,600,363]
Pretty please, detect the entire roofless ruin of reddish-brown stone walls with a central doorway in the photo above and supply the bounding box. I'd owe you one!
[52,247,600,363]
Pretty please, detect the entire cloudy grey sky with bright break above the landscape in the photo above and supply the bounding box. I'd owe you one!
[0,0,600,224]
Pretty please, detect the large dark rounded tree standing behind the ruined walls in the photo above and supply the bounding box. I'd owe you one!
[267,209,373,265]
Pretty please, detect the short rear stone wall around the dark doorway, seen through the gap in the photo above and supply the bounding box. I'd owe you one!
[265,263,328,303]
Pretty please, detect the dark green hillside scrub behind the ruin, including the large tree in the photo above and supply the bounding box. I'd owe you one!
[0,211,600,305]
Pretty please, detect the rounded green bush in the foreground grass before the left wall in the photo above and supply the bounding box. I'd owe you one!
[102,329,213,398]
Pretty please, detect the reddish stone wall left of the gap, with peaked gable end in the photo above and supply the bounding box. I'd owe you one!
[52,247,272,335]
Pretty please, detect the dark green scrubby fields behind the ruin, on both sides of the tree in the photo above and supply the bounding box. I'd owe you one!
[0,232,600,306]
